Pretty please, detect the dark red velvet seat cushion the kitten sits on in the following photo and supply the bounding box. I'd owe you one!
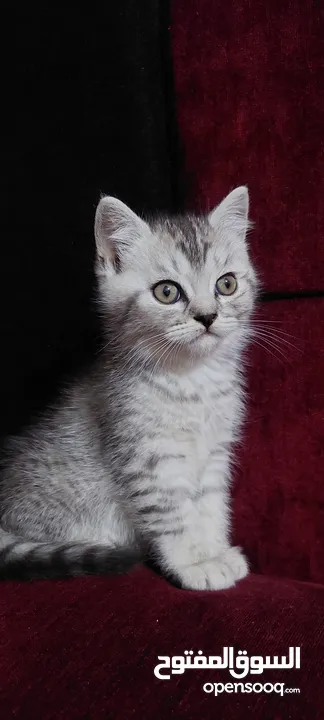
[0,568,324,720]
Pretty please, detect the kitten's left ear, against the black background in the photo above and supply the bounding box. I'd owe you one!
[94,196,149,270]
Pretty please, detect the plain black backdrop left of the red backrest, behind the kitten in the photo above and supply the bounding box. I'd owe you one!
[0,0,181,435]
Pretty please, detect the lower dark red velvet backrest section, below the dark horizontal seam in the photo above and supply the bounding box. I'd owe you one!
[234,298,324,583]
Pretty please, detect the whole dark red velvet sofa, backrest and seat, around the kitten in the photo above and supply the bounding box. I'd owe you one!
[0,0,324,720]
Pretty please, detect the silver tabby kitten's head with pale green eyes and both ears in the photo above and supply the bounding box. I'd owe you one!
[95,187,257,369]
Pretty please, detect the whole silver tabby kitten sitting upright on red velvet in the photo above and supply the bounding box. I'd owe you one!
[0,187,257,590]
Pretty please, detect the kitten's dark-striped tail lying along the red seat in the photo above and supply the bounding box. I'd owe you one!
[0,528,141,581]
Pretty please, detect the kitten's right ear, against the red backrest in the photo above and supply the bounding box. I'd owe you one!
[208,186,250,241]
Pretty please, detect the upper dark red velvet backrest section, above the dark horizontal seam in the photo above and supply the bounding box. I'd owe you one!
[172,0,324,290]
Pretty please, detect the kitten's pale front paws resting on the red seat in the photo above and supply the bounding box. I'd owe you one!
[179,547,249,590]
